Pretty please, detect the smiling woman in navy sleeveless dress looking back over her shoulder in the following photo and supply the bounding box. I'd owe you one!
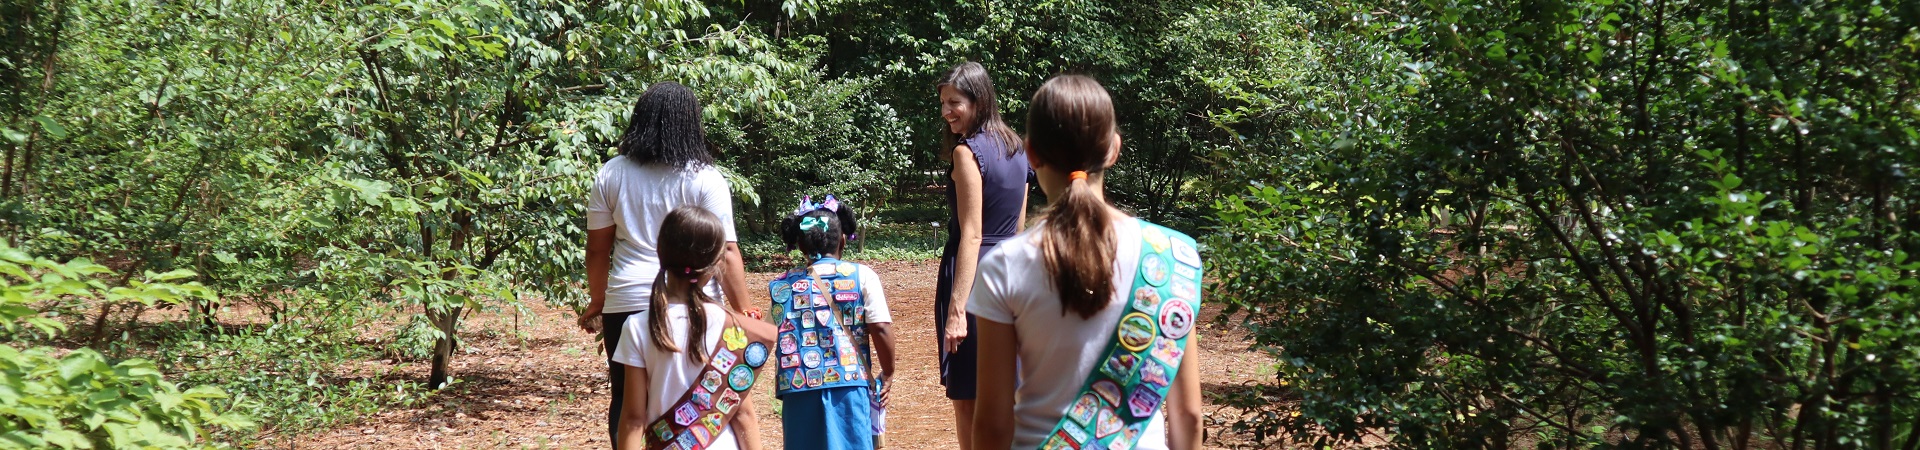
[933,62,1029,448]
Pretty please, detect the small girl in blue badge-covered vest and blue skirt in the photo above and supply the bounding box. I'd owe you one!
[768,196,893,450]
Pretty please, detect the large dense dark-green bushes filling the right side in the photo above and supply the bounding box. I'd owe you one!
[1210,2,1920,448]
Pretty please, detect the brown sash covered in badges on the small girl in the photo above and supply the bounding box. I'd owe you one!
[636,313,768,450]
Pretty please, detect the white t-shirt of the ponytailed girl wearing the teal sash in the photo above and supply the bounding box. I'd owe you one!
[966,217,1167,450]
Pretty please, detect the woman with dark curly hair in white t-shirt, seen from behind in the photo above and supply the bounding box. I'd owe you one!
[580,81,758,450]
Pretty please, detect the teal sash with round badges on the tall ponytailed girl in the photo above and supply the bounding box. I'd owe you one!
[1041,221,1200,450]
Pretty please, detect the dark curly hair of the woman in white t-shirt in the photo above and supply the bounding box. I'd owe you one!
[618,81,714,167]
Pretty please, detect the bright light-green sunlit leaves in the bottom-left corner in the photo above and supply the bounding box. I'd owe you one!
[0,246,253,448]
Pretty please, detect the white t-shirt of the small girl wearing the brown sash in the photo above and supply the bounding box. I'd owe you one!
[612,304,739,450]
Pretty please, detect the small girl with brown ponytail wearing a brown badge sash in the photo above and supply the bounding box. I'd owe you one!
[612,206,774,450]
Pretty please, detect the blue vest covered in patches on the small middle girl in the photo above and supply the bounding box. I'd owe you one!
[768,258,868,396]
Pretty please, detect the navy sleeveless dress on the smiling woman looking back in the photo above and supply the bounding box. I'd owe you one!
[933,133,1031,400]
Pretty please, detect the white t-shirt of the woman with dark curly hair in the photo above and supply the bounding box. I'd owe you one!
[588,156,739,313]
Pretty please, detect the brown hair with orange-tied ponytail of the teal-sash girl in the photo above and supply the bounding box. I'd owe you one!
[1027,75,1117,317]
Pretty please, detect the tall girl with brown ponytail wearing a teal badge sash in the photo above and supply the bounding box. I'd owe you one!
[968,75,1202,450]
